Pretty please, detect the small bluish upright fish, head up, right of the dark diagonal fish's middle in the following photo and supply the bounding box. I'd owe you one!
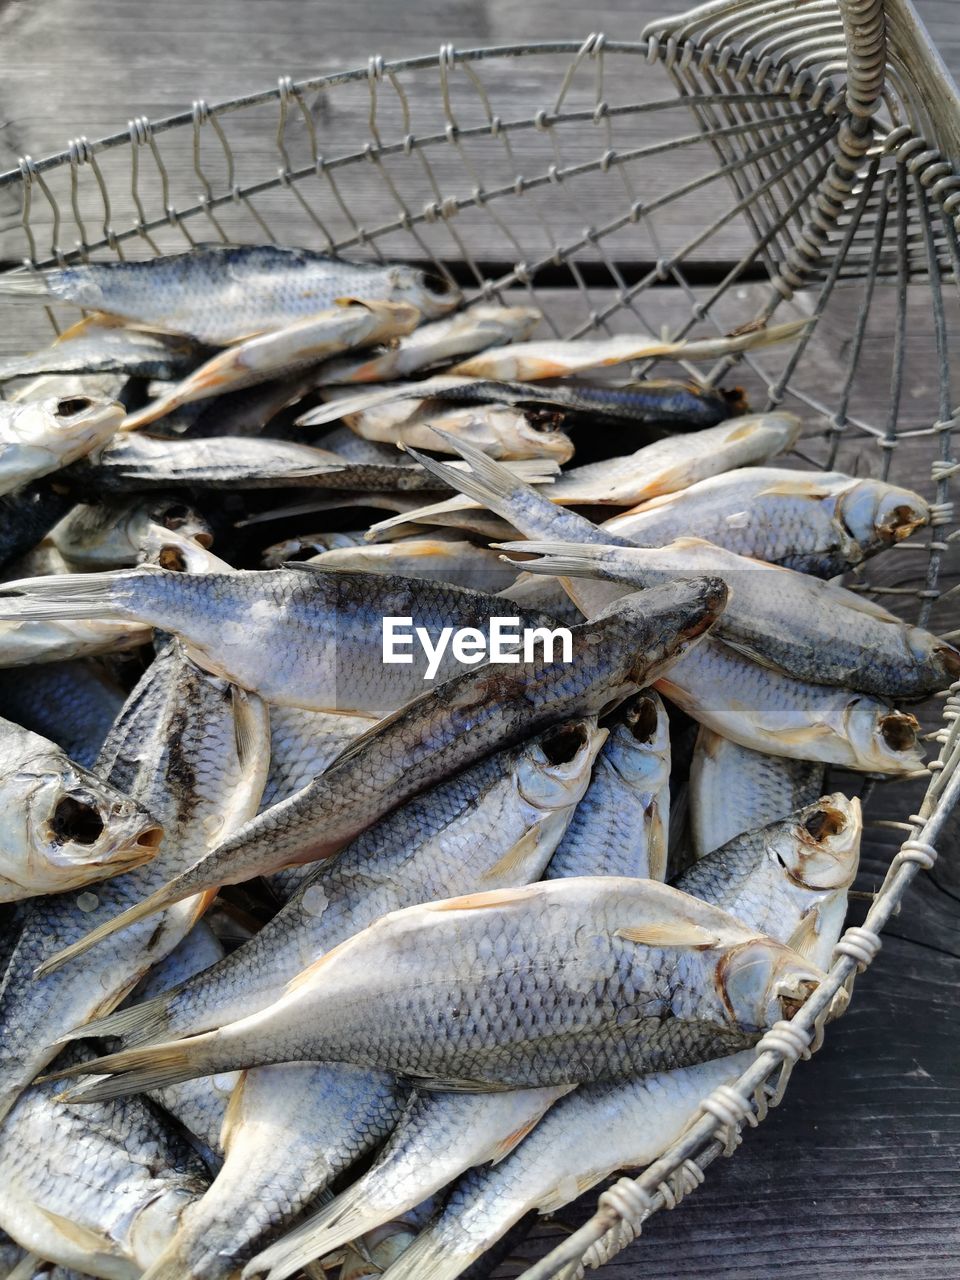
[544,691,671,881]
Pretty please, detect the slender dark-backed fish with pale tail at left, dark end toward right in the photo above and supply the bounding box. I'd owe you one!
[297,374,731,426]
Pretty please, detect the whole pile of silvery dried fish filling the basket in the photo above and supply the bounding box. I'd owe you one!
[0,246,960,1280]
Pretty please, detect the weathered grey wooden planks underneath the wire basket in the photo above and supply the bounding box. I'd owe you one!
[0,0,960,1280]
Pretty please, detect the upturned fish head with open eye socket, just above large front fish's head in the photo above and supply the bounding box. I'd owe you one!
[774,791,863,891]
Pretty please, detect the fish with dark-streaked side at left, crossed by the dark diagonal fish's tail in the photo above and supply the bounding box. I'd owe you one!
[0,645,269,1115]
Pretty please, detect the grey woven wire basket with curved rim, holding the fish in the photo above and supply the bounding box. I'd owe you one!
[0,0,960,1280]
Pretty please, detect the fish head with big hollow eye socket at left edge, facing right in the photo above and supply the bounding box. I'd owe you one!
[19,756,163,884]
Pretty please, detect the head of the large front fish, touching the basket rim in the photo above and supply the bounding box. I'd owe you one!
[714,937,826,1032]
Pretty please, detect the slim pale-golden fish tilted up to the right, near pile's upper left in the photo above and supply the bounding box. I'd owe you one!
[122,300,420,431]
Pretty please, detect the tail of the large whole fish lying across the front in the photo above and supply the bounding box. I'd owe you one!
[47,1032,231,1102]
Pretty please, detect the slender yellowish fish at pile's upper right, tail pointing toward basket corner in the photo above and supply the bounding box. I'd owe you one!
[451,320,810,383]
